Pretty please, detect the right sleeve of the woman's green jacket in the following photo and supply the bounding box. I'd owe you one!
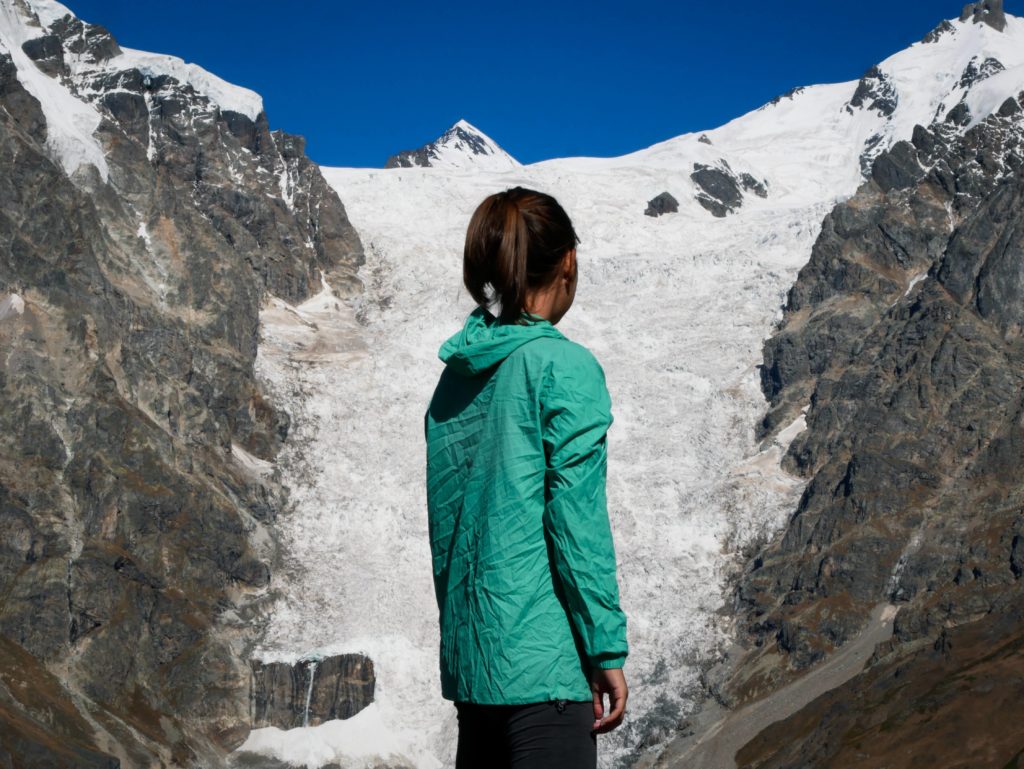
[541,346,629,668]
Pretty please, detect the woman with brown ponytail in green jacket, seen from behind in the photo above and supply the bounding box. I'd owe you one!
[424,187,629,769]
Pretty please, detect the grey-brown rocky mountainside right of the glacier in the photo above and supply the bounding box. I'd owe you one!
[727,88,1024,767]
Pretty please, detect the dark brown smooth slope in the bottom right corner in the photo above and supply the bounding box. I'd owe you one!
[735,596,1024,769]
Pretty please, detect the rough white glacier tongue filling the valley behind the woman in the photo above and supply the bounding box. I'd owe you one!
[253,163,825,767]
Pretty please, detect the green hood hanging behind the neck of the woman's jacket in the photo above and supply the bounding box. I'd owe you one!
[437,307,565,377]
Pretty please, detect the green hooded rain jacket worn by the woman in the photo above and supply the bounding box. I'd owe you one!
[424,307,629,704]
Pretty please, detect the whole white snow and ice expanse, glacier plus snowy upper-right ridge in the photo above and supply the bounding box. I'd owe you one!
[241,7,1024,767]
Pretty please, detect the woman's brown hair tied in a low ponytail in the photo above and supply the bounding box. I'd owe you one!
[462,186,580,323]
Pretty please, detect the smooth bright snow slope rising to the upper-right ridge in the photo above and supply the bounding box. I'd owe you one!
[589,16,1024,210]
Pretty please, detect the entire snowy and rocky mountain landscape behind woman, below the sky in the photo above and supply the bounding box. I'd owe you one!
[6,0,1024,769]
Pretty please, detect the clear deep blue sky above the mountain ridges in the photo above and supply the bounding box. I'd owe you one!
[66,0,1024,167]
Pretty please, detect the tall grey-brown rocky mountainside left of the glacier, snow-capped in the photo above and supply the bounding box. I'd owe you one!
[0,0,362,767]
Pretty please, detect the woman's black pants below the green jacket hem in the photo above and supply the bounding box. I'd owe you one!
[455,699,597,769]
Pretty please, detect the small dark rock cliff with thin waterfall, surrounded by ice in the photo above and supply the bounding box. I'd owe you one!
[252,654,376,729]
